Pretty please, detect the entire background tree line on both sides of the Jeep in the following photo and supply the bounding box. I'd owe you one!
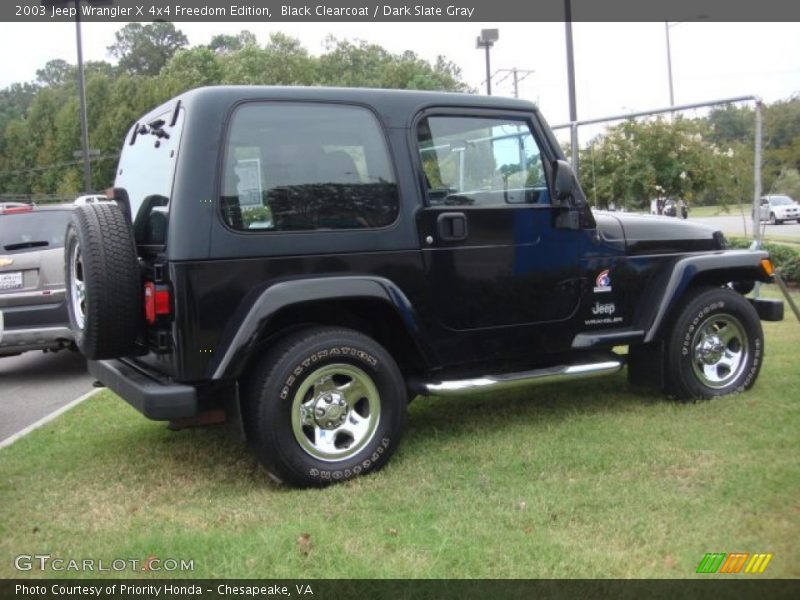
[0,22,800,209]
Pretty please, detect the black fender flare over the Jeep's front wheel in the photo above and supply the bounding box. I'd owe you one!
[636,250,773,343]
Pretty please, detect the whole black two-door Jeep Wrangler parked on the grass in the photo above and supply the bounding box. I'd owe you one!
[66,87,783,485]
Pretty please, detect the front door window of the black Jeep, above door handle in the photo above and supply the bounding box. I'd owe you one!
[417,117,550,206]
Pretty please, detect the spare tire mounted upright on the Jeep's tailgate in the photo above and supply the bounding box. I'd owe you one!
[64,203,144,360]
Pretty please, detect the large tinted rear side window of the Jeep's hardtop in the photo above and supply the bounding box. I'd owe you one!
[220,103,399,231]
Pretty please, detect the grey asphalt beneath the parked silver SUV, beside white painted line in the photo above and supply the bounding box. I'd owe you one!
[0,350,94,442]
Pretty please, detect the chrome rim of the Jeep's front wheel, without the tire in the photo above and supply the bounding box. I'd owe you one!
[691,314,750,389]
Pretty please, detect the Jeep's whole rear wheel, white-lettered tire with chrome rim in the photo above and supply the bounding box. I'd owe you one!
[245,327,407,486]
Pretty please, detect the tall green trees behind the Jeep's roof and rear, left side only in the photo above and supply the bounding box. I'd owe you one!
[0,22,471,198]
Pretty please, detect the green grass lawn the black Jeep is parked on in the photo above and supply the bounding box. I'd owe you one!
[0,292,800,578]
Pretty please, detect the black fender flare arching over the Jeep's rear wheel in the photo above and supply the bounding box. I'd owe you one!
[207,276,432,379]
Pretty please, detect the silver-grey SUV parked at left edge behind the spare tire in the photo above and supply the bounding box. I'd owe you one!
[0,205,74,357]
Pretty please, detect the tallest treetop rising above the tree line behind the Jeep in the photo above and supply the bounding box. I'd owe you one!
[108,21,189,75]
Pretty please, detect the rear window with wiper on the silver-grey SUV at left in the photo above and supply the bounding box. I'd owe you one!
[0,210,71,254]
